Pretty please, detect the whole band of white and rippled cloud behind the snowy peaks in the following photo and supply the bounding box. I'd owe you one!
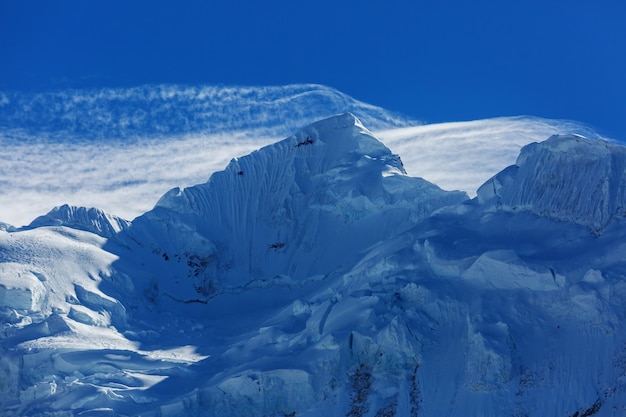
[0,84,599,226]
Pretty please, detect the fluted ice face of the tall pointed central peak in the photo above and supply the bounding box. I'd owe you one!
[128,114,467,295]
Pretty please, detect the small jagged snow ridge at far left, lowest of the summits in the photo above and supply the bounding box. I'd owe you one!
[27,204,130,238]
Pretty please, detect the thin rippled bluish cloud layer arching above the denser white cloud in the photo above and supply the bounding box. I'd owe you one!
[0,84,420,140]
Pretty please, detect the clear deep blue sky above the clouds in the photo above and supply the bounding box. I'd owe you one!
[0,0,626,139]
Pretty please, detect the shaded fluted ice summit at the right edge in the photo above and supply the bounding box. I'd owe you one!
[478,135,626,233]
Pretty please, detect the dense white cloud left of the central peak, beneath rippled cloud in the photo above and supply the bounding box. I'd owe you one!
[0,131,275,226]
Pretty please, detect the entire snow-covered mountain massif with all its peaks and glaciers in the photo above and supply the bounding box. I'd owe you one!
[0,114,626,417]
